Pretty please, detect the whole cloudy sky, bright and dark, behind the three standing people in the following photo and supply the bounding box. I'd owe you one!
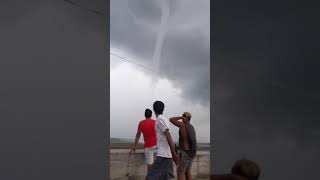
[110,0,210,142]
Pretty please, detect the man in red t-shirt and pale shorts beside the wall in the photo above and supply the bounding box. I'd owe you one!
[130,109,157,171]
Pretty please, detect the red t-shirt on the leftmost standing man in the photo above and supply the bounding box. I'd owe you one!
[138,119,157,148]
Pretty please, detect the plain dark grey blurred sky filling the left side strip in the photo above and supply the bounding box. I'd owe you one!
[0,0,108,180]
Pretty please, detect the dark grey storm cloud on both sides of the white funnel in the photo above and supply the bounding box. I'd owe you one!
[110,0,210,104]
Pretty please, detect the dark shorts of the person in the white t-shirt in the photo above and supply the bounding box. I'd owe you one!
[146,156,174,180]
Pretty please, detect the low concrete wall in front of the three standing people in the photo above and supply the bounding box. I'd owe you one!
[110,149,210,180]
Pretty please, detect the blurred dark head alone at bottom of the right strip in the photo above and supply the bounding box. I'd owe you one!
[231,159,260,180]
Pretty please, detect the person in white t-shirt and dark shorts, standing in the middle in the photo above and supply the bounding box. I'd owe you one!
[146,101,178,180]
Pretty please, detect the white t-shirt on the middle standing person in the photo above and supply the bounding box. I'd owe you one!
[155,115,172,158]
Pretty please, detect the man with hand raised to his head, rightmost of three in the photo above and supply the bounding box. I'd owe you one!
[170,112,197,180]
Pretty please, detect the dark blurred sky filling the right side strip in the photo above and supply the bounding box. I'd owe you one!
[212,1,320,179]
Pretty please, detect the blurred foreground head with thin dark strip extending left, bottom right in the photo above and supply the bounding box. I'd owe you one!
[210,159,260,180]
